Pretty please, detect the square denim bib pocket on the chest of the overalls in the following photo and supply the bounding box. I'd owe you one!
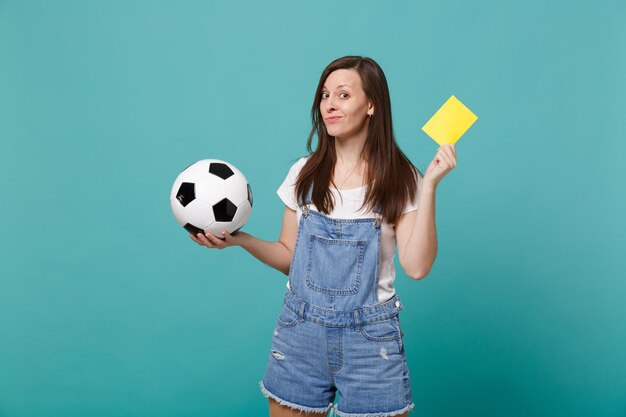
[306,234,366,295]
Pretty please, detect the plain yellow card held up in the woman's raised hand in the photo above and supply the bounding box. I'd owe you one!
[422,96,478,145]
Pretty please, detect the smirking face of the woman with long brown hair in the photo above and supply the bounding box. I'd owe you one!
[320,69,373,138]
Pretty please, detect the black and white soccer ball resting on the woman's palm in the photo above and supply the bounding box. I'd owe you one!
[170,159,252,239]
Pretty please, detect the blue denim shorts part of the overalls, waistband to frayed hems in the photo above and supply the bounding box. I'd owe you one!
[259,292,414,417]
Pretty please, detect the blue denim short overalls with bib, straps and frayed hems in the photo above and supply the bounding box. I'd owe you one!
[259,188,414,417]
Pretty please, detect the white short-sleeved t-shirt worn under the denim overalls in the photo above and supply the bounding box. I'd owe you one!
[276,156,422,303]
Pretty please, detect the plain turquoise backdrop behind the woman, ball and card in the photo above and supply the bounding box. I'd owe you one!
[0,0,626,417]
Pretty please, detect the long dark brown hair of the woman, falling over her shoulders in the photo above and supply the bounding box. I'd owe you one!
[295,56,421,224]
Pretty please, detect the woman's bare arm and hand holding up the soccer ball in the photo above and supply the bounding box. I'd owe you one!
[190,206,298,275]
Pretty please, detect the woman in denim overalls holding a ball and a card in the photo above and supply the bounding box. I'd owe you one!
[190,56,456,417]
